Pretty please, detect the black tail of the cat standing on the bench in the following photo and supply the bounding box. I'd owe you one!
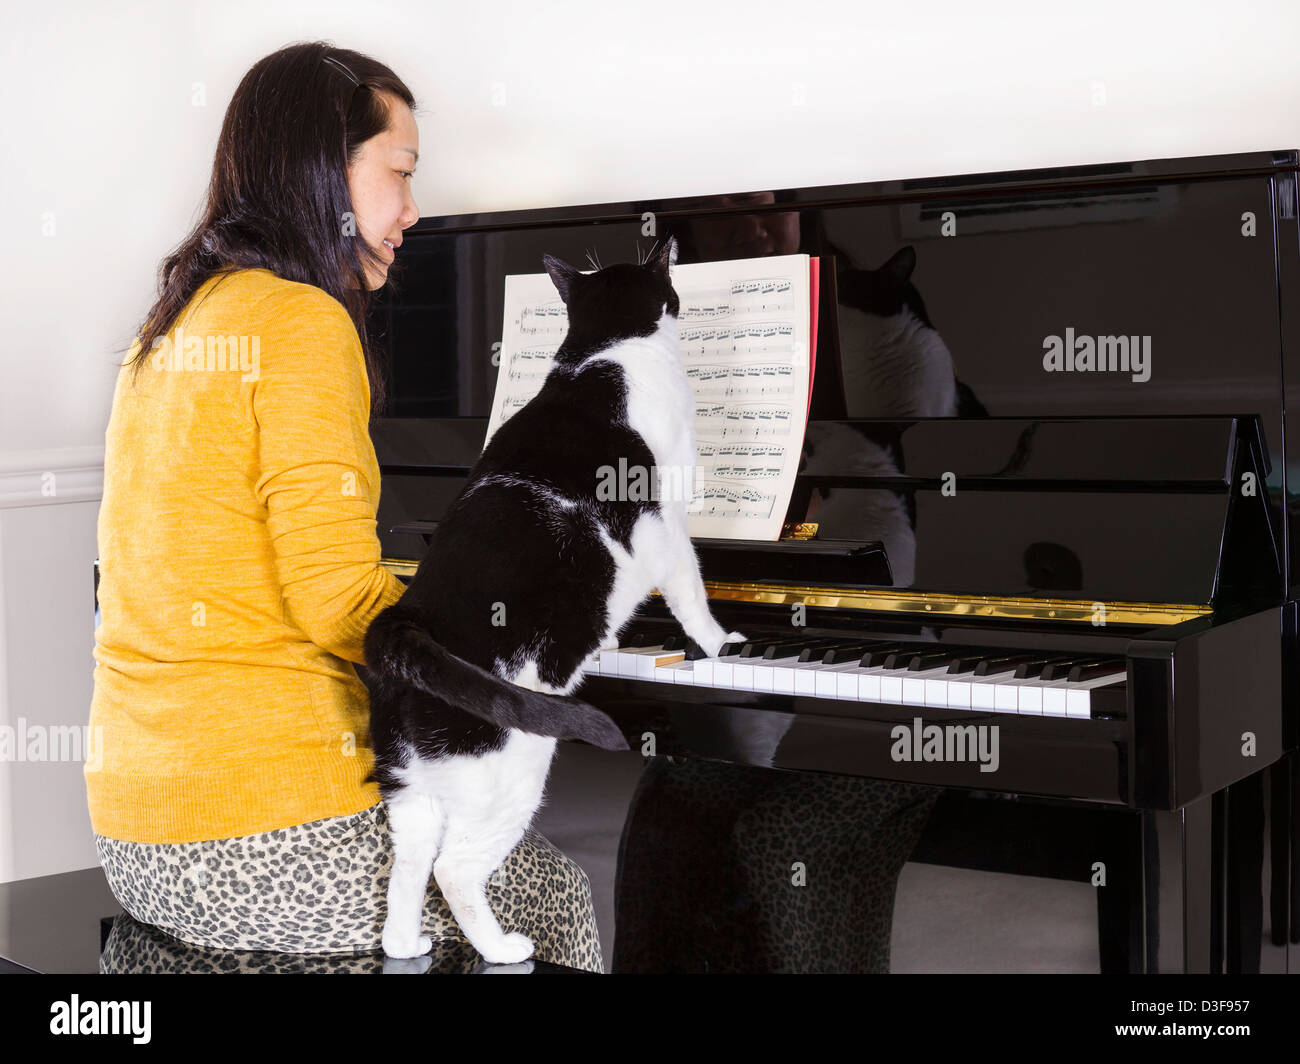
[365,606,628,751]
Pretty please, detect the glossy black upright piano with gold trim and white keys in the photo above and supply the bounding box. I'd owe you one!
[371,151,1300,972]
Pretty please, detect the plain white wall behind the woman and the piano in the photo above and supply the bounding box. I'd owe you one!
[0,0,1300,881]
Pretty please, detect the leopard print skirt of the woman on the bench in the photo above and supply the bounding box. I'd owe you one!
[95,803,605,972]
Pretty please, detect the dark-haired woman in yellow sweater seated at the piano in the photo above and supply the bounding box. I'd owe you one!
[86,43,602,970]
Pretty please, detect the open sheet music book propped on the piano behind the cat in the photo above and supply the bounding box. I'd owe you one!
[484,255,819,540]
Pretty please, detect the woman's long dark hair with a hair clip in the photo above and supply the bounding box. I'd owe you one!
[126,42,415,412]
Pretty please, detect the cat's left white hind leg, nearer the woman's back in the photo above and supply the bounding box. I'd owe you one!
[384,787,446,957]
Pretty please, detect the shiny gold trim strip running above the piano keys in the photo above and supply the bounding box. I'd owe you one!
[380,558,1214,624]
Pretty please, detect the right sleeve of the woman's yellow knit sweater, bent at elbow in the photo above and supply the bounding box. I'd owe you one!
[252,287,404,665]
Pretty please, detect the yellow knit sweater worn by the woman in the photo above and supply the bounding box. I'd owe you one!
[86,269,404,843]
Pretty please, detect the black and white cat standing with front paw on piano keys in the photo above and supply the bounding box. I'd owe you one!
[365,239,742,964]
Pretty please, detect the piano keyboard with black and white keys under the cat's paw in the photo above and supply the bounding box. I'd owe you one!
[582,630,1127,719]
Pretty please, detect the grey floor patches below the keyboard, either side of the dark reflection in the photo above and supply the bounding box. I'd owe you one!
[534,743,1099,973]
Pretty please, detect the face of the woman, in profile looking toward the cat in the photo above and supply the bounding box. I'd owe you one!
[347,92,420,291]
